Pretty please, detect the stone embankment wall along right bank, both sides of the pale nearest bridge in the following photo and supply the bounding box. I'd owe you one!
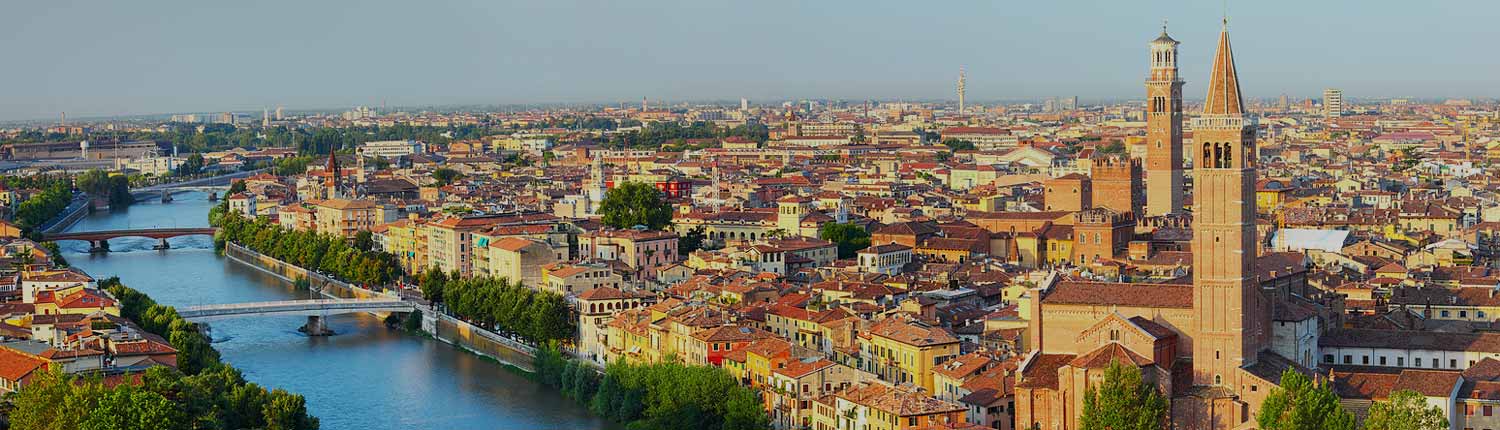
[224,243,536,373]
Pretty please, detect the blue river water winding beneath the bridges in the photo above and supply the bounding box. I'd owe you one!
[60,193,614,429]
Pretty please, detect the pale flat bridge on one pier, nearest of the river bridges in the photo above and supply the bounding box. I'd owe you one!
[177,298,417,336]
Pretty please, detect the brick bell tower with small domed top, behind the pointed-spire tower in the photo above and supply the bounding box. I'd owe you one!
[1145,24,1184,216]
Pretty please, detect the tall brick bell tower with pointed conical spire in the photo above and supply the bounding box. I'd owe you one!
[1193,21,1271,393]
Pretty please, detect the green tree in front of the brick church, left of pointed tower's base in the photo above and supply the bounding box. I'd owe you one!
[1079,361,1167,430]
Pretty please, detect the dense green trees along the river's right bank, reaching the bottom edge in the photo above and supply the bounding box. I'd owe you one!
[534,345,771,430]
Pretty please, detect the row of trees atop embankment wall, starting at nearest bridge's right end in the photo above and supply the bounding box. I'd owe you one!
[419,268,578,345]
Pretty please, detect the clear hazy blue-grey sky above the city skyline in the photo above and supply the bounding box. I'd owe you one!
[0,0,1500,121]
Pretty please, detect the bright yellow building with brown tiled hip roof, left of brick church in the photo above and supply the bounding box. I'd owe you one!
[858,316,959,393]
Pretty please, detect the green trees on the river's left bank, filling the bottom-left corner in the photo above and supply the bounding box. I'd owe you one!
[9,277,318,430]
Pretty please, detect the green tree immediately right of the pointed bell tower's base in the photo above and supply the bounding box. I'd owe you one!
[1256,367,1355,430]
